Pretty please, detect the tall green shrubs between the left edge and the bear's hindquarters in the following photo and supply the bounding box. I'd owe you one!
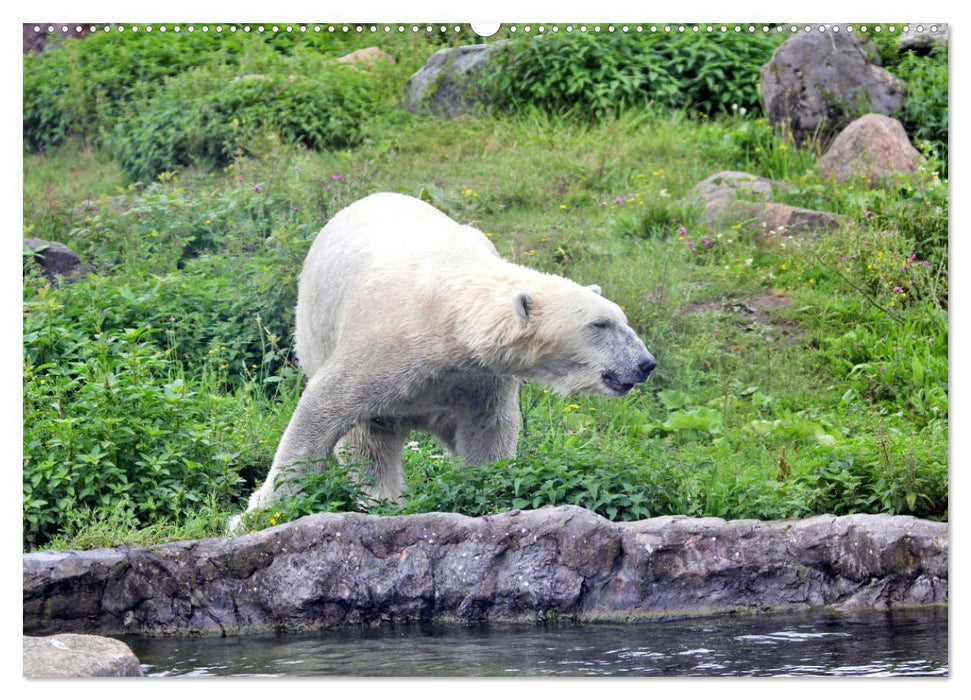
[23,260,312,546]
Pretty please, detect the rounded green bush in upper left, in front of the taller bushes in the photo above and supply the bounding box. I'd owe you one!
[112,61,381,180]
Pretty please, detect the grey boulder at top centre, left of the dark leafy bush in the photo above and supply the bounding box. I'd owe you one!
[405,40,509,118]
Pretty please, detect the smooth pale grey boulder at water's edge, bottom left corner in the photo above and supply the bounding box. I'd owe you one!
[24,634,142,678]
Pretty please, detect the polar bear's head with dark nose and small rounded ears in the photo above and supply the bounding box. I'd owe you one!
[513,278,657,396]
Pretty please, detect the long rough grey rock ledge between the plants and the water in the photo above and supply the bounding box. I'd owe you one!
[23,506,948,634]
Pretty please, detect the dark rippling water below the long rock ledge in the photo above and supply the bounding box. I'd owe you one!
[122,608,948,677]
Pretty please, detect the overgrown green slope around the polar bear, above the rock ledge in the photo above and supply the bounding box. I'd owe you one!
[24,102,948,547]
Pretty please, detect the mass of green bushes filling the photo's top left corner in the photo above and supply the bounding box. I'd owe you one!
[23,31,408,165]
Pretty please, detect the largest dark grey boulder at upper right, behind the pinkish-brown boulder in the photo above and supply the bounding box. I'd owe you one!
[759,31,904,143]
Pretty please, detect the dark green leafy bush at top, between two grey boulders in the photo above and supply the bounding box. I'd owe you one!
[485,33,779,118]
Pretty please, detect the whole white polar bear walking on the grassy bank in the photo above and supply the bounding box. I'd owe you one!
[235,193,656,524]
